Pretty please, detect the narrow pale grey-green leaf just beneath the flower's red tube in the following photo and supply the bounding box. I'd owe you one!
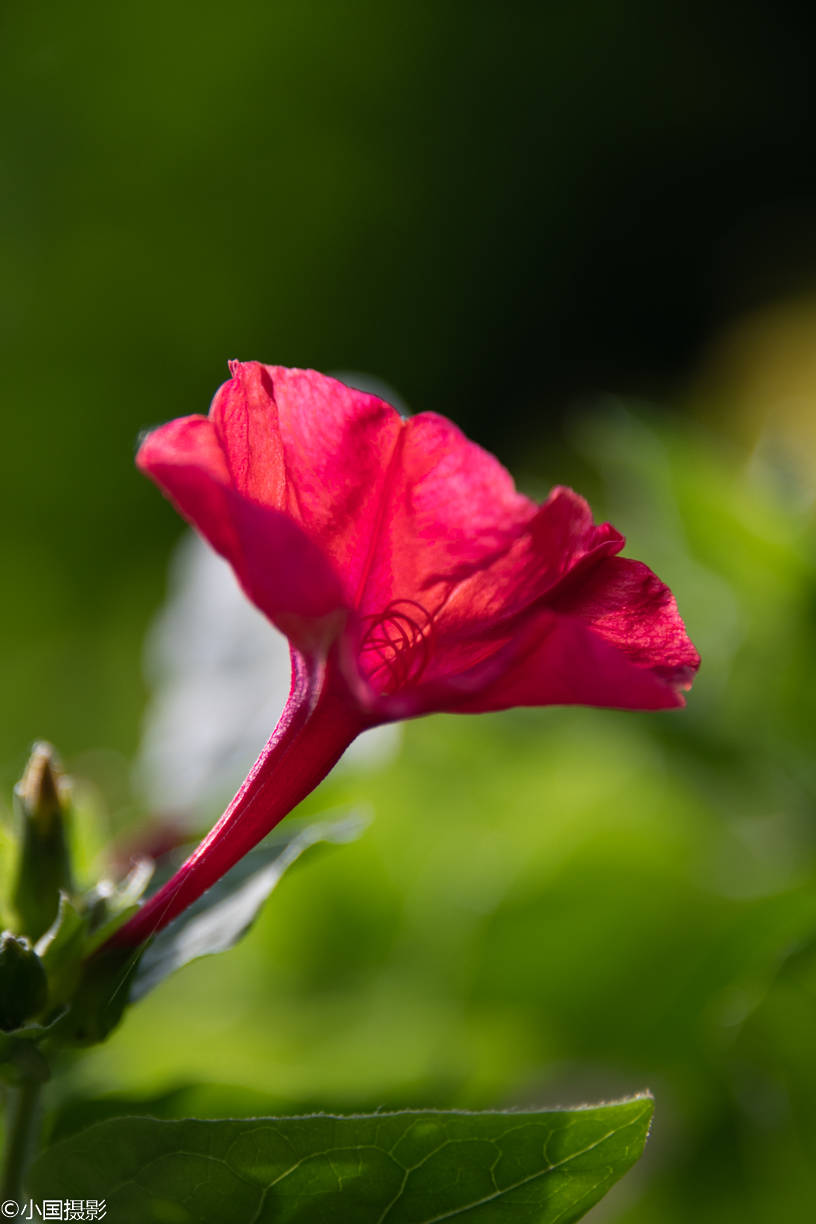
[130,815,366,1002]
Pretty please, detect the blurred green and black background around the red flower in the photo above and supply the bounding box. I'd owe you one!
[0,0,816,1224]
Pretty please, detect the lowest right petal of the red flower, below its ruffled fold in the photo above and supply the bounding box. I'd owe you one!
[360,541,700,717]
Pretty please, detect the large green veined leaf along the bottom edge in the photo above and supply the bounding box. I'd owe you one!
[28,1095,653,1224]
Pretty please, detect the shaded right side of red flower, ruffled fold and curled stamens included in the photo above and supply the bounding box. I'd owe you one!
[347,488,700,718]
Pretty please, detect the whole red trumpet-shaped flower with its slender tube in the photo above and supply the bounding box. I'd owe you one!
[111,362,700,944]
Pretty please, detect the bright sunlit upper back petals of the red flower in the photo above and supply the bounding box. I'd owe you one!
[210,362,536,613]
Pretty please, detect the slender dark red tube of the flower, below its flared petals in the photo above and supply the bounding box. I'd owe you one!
[106,652,365,947]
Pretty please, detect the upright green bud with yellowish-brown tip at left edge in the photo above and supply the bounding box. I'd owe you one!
[11,743,71,940]
